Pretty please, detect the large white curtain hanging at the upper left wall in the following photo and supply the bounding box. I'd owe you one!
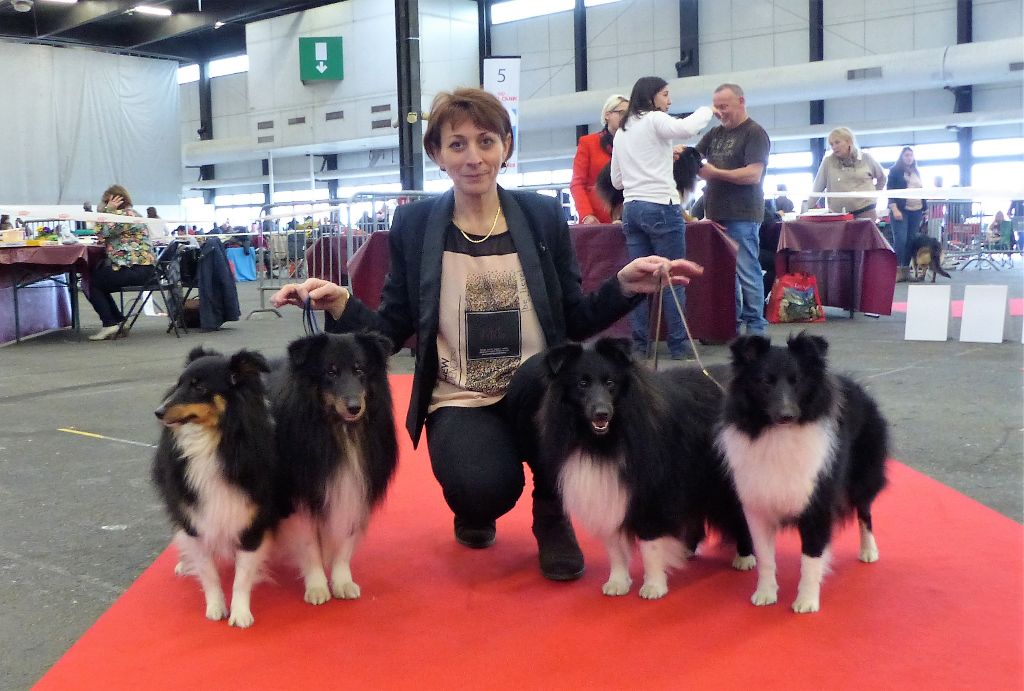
[0,43,181,208]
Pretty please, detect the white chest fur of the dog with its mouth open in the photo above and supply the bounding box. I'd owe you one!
[558,451,629,536]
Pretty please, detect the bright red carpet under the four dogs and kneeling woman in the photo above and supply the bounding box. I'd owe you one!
[37,376,1024,691]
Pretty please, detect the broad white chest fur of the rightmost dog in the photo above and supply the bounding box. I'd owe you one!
[719,420,837,519]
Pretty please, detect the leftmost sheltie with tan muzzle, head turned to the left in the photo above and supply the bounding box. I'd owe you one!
[153,348,283,628]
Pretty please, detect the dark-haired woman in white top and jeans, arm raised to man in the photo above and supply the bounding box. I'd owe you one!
[611,77,715,359]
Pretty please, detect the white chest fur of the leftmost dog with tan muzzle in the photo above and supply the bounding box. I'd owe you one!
[174,424,256,554]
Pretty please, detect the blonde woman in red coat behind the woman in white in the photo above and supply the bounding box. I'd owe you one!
[569,93,630,223]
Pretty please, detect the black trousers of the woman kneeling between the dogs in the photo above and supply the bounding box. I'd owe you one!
[426,356,559,524]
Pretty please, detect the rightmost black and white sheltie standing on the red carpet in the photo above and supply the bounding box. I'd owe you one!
[719,334,889,612]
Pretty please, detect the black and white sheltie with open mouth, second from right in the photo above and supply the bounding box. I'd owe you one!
[537,338,755,599]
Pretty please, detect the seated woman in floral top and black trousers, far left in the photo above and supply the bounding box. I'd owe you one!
[86,184,157,341]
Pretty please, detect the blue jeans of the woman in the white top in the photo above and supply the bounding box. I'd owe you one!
[623,201,689,355]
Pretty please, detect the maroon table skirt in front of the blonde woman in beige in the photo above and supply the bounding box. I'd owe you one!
[775,219,896,314]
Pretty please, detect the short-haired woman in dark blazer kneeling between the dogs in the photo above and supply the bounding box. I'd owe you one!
[271,88,700,580]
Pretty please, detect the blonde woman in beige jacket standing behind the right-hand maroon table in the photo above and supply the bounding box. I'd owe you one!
[811,127,886,221]
